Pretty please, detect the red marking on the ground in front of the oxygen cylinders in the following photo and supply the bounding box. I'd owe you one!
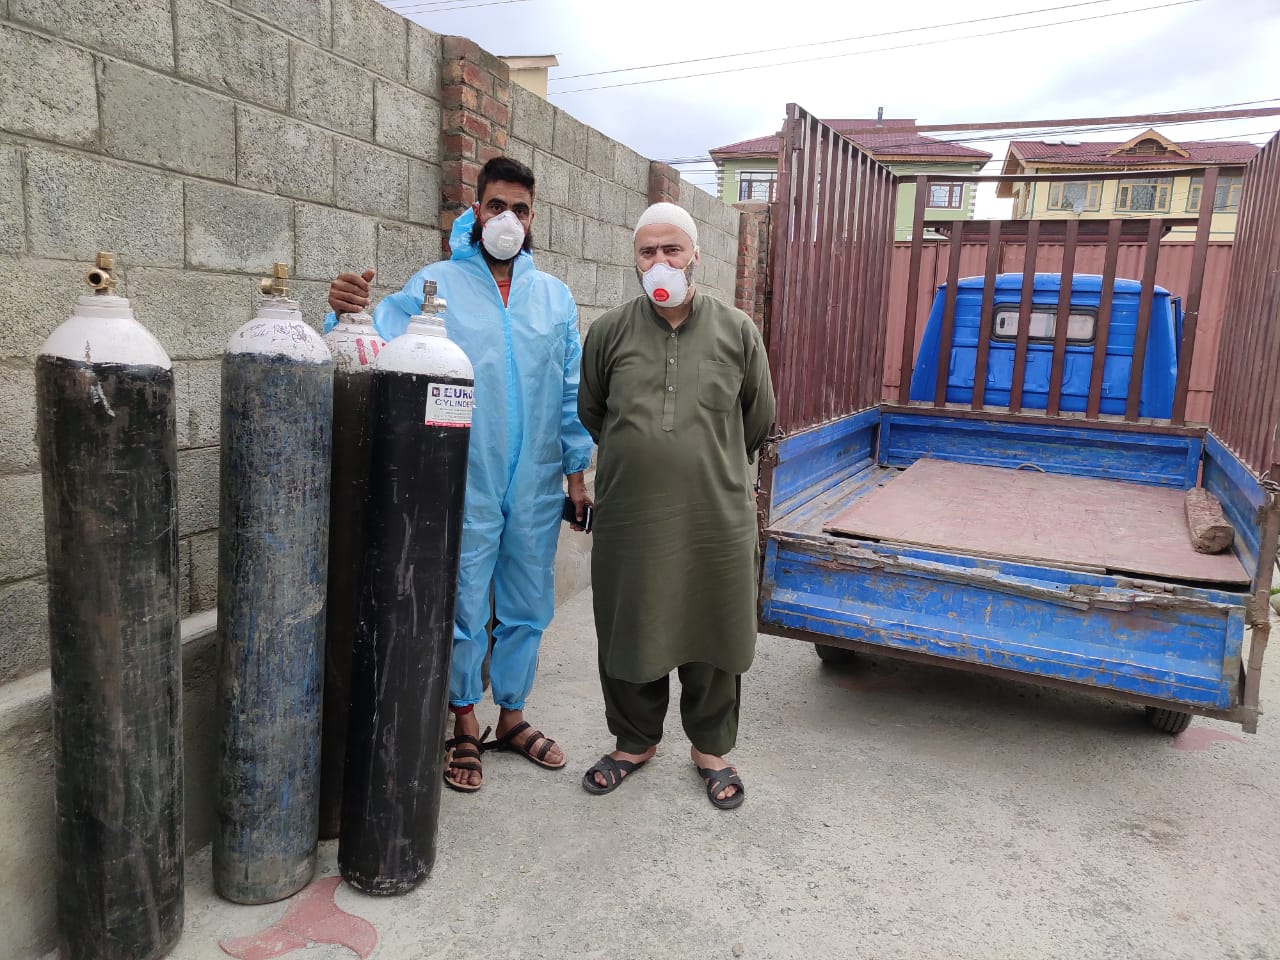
[218,877,378,960]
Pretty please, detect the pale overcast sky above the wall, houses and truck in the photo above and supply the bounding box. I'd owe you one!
[384,0,1280,215]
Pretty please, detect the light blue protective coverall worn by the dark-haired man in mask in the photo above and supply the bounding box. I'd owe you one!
[325,210,593,710]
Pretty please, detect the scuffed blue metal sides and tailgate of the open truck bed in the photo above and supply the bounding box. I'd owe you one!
[760,408,1263,727]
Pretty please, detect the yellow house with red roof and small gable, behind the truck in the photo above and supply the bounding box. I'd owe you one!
[996,129,1258,241]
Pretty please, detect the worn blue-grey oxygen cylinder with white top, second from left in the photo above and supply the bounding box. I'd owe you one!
[214,264,333,904]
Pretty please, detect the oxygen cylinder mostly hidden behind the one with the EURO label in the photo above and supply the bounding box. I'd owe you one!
[320,312,385,840]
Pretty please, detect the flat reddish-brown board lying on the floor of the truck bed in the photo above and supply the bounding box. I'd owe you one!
[823,460,1251,585]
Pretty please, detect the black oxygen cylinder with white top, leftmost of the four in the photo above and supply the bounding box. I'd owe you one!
[36,253,183,960]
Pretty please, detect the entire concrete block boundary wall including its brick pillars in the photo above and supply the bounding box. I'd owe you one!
[0,0,740,957]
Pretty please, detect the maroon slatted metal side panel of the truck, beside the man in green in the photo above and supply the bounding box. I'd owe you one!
[764,104,897,434]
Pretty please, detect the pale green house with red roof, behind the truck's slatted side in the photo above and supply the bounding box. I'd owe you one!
[709,118,991,239]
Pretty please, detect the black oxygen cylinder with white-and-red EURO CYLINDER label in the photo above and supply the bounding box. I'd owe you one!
[338,280,474,895]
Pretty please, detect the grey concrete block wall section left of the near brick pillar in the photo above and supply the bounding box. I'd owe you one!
[0,0,440,682]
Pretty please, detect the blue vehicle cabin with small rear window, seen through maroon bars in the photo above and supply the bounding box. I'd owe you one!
[910,273,1183,417]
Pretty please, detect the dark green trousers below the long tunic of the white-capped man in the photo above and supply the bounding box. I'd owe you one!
[600,663,742,756]
